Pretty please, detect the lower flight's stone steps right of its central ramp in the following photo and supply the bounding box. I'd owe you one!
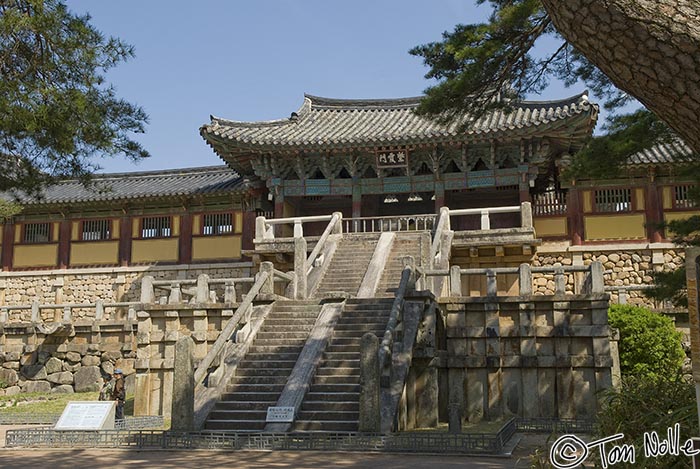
[293,298,393,432]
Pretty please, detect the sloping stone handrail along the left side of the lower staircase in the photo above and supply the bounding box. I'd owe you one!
[194,262,274,387]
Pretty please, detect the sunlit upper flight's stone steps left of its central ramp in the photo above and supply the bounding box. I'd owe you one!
[316,234,379,297]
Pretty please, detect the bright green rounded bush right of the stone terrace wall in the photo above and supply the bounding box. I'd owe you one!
[608,305,685,379]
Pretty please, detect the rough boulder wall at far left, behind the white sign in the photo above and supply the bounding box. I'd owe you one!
[0,321,136,395]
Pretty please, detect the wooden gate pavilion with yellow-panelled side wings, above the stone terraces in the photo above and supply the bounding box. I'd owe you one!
[0,93,700,301]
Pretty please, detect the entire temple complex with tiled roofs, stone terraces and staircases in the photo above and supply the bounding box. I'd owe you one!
[0,89,700,433]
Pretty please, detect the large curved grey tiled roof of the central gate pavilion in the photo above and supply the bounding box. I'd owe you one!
[200,92,598,174]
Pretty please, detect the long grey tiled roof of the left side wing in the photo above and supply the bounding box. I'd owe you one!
[6,165,245,204]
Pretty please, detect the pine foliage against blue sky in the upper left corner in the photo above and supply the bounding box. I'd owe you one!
[0,0,148,193]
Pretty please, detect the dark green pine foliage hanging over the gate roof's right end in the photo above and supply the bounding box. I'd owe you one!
[410,0,700,304]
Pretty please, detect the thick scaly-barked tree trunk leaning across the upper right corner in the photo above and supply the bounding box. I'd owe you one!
[542,0,700,154]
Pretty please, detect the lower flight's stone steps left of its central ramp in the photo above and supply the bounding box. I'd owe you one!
[204,300,321,431]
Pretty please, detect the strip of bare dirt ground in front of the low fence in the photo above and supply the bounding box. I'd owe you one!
[0,426,546,469]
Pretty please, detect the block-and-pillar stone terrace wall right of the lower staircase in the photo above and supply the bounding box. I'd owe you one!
[441,293,619,422]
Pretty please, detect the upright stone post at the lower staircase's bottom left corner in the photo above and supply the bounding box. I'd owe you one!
[170,337,194,432]
